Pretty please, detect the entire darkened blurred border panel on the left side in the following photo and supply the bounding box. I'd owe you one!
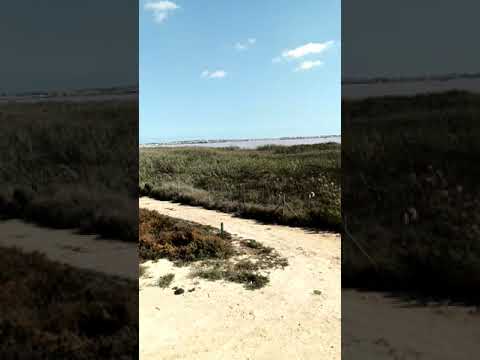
[0,0,139,359]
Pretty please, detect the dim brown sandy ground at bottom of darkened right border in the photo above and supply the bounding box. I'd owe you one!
[342,290,480,360]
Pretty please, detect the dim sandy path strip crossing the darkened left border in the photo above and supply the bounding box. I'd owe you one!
[0,220,138,280]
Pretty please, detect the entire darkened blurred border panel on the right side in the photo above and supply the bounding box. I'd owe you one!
[342,0,480,359]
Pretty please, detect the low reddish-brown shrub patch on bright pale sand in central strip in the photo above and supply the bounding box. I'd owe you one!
[139,209,288,290]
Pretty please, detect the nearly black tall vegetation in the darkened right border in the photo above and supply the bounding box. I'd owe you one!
[342,92,480,302]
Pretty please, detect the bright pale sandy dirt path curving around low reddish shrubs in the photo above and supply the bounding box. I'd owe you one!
[139,198,341,360]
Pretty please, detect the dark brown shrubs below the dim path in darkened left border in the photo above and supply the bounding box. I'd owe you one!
[0,248,138,360]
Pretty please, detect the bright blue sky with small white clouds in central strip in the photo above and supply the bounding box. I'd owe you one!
[139,0,341,142]
